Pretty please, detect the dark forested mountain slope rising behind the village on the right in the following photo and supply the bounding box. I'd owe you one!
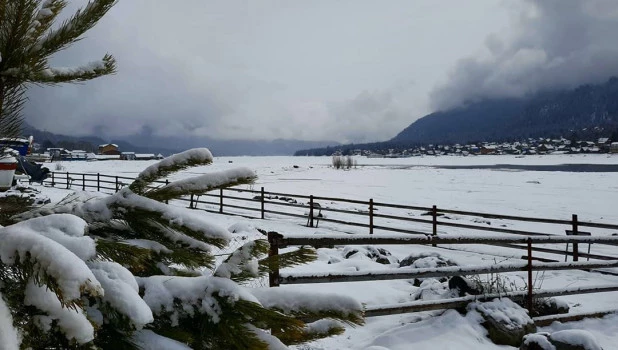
[390,78,618,143]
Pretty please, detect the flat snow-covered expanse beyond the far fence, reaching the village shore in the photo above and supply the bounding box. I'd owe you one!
[54,155,618,222]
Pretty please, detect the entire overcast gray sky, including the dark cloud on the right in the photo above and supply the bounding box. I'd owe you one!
[26,0,618,142]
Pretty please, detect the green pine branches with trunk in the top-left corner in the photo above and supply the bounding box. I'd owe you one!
[0,0,116,137]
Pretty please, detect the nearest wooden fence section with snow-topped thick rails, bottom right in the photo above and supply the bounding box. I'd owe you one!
[268,232,618,317]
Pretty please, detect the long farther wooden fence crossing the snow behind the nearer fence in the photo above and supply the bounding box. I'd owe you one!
[45,172,618,261]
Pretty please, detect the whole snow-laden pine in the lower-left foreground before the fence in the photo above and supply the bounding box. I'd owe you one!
[7,149,363,349]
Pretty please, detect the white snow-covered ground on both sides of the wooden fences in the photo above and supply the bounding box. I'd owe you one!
[32,155,618,350]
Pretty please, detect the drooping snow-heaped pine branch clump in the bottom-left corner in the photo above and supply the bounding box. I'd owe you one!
[0,215,104,349]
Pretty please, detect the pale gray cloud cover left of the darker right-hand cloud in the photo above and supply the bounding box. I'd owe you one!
[26,0,510,142]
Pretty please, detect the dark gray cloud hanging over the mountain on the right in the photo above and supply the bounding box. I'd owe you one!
[430,0,618,109]
